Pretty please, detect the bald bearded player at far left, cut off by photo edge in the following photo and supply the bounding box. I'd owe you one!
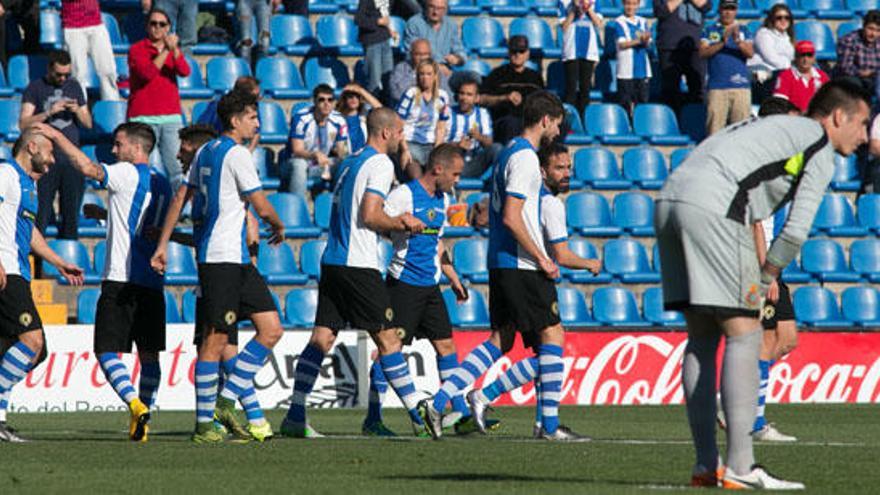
[0,124,83,442]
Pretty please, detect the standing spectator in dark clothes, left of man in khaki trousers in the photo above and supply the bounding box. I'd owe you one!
[653,0,712,111]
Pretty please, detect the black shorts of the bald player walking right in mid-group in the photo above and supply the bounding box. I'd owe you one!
[315,265,394,332]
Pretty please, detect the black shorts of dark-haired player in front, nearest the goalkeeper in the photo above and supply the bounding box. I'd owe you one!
[489,268,561,347]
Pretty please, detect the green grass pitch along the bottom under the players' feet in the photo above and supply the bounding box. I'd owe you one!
[0,405,880,495]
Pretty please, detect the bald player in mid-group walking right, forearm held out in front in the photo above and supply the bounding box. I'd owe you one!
[281,107,425,438]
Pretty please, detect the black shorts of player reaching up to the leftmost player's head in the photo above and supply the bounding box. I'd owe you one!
[93,280,165,354]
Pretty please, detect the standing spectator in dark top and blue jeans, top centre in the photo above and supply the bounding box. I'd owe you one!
[354,0,400,99]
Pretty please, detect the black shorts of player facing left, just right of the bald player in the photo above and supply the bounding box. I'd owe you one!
[385,276,452,345]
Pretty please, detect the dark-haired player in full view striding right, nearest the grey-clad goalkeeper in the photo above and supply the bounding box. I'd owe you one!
[419,91,582,441]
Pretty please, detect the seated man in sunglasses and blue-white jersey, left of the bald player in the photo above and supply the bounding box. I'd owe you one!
[280,84,348,197]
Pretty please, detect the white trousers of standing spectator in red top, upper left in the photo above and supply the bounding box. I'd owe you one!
[64,24,120,100]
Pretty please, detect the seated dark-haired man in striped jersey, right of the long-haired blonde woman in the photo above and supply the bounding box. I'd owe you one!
[447,81,502,177]
